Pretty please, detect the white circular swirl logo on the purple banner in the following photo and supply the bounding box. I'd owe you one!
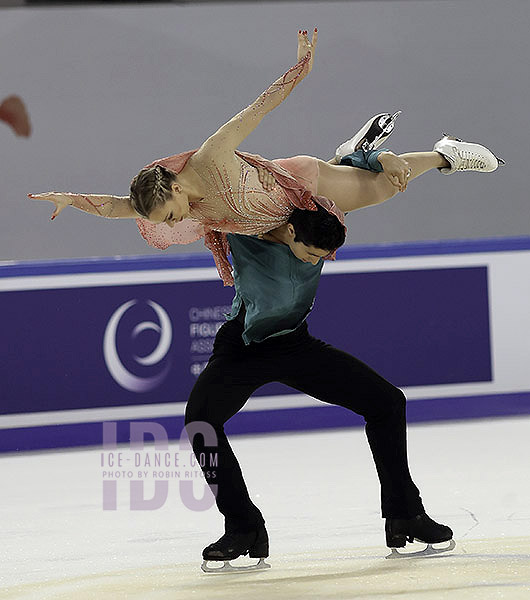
[103,300,172,393]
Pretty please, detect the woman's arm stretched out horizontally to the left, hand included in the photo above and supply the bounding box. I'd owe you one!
[28,192,140,221]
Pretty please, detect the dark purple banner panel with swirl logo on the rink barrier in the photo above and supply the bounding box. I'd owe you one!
[1,267,491,414]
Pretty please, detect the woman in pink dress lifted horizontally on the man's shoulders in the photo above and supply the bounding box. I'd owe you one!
[29,29,498,285]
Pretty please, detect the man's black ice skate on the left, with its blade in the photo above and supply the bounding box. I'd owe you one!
[201,526,270,573]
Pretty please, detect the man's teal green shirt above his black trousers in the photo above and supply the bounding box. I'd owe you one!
[227,233,324,345]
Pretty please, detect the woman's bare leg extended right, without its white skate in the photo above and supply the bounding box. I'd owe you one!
[318,152,448,212]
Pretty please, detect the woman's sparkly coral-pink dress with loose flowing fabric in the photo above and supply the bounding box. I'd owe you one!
[136,150,344,285]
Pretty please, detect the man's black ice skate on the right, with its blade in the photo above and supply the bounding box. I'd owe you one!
[385,513,456,558]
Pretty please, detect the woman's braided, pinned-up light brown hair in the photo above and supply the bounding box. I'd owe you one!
[129,165,177,219]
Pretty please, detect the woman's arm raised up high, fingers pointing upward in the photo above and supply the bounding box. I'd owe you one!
[199,28,317,152]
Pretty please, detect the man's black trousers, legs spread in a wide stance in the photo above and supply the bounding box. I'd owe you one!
[186,320,424,530]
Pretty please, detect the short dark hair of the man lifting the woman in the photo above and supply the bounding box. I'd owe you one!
[289,204,346,252]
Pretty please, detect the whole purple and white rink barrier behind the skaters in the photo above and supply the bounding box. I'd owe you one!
[0,238,530,452]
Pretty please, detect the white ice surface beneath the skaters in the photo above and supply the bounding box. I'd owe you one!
[0,417,530,600]
